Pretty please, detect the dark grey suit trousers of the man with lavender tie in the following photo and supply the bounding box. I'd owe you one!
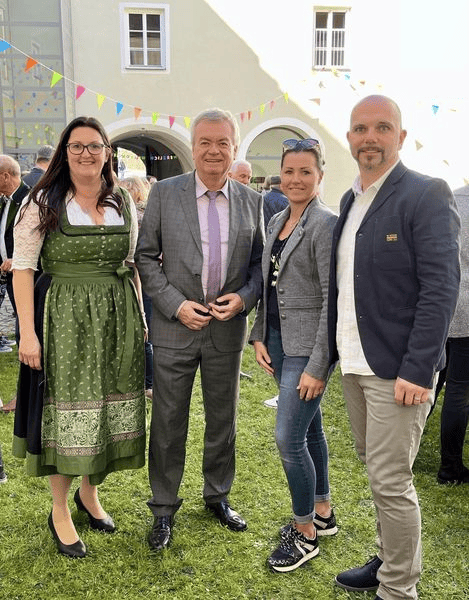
[148,326,242,516]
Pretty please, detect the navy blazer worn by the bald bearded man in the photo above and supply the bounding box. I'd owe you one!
[328,162,460,388]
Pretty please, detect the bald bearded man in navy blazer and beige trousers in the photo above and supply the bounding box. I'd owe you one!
[329,96,460,600]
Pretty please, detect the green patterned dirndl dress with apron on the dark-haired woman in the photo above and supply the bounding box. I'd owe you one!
[13,200,145,485]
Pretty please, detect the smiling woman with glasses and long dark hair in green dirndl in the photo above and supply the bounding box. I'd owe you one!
[12,117,146,557]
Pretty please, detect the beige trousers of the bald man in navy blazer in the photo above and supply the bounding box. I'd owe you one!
[342,374,434,600]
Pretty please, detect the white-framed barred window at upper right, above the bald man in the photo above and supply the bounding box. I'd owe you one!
[313,8,349,69]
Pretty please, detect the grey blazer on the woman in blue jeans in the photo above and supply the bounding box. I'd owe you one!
[249,198,337,379]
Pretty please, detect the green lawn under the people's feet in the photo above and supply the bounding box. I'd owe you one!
[0,347,469,600]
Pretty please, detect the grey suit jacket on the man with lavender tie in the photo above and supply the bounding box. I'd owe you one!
[135,172,264,352]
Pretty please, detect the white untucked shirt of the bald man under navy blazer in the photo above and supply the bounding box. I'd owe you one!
[336,161,399,375]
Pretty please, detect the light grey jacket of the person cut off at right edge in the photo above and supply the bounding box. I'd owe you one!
[448,185,469,337]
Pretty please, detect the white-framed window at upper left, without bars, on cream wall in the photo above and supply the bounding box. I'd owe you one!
[120,2,169,70]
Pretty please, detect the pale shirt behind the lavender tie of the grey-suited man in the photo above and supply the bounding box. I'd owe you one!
[195,171,230,296]
